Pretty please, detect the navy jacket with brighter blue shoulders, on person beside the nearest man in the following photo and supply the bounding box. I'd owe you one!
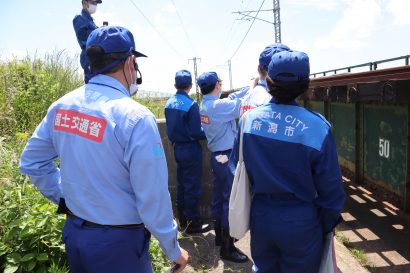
[165,90,206,143]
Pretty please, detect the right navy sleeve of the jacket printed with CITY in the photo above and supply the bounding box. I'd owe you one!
[312,129,346,233]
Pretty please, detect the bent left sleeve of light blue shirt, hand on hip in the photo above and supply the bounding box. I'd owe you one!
[19,111,63,204]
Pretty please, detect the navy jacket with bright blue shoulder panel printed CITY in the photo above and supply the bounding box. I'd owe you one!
[229,99,345,232]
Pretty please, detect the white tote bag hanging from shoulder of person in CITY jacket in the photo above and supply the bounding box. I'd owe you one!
[228,115,252,239]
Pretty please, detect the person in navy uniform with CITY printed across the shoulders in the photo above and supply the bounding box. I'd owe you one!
[229,50,345,273]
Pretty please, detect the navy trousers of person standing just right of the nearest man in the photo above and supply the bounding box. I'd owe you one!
[174,141,202,221]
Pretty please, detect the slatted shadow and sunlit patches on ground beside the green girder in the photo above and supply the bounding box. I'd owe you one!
[339,178,410,273]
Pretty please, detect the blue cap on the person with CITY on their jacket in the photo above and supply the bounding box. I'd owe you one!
[268,50,310,82]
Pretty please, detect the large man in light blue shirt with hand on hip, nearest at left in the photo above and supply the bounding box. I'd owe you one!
[20,27,188,273]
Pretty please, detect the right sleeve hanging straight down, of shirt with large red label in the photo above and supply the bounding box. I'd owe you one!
[124,115,181,261]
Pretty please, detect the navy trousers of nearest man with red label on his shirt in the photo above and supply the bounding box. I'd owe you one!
[63,217,154,273]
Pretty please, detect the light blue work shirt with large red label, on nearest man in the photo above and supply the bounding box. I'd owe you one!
[20,75,181,260]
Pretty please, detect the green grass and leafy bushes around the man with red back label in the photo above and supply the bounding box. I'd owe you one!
[0,51,169,273]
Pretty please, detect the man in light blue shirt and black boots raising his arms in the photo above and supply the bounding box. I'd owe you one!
[198,72,248,263]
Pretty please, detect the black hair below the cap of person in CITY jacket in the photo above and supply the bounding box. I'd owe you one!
[266,76,310,103]
